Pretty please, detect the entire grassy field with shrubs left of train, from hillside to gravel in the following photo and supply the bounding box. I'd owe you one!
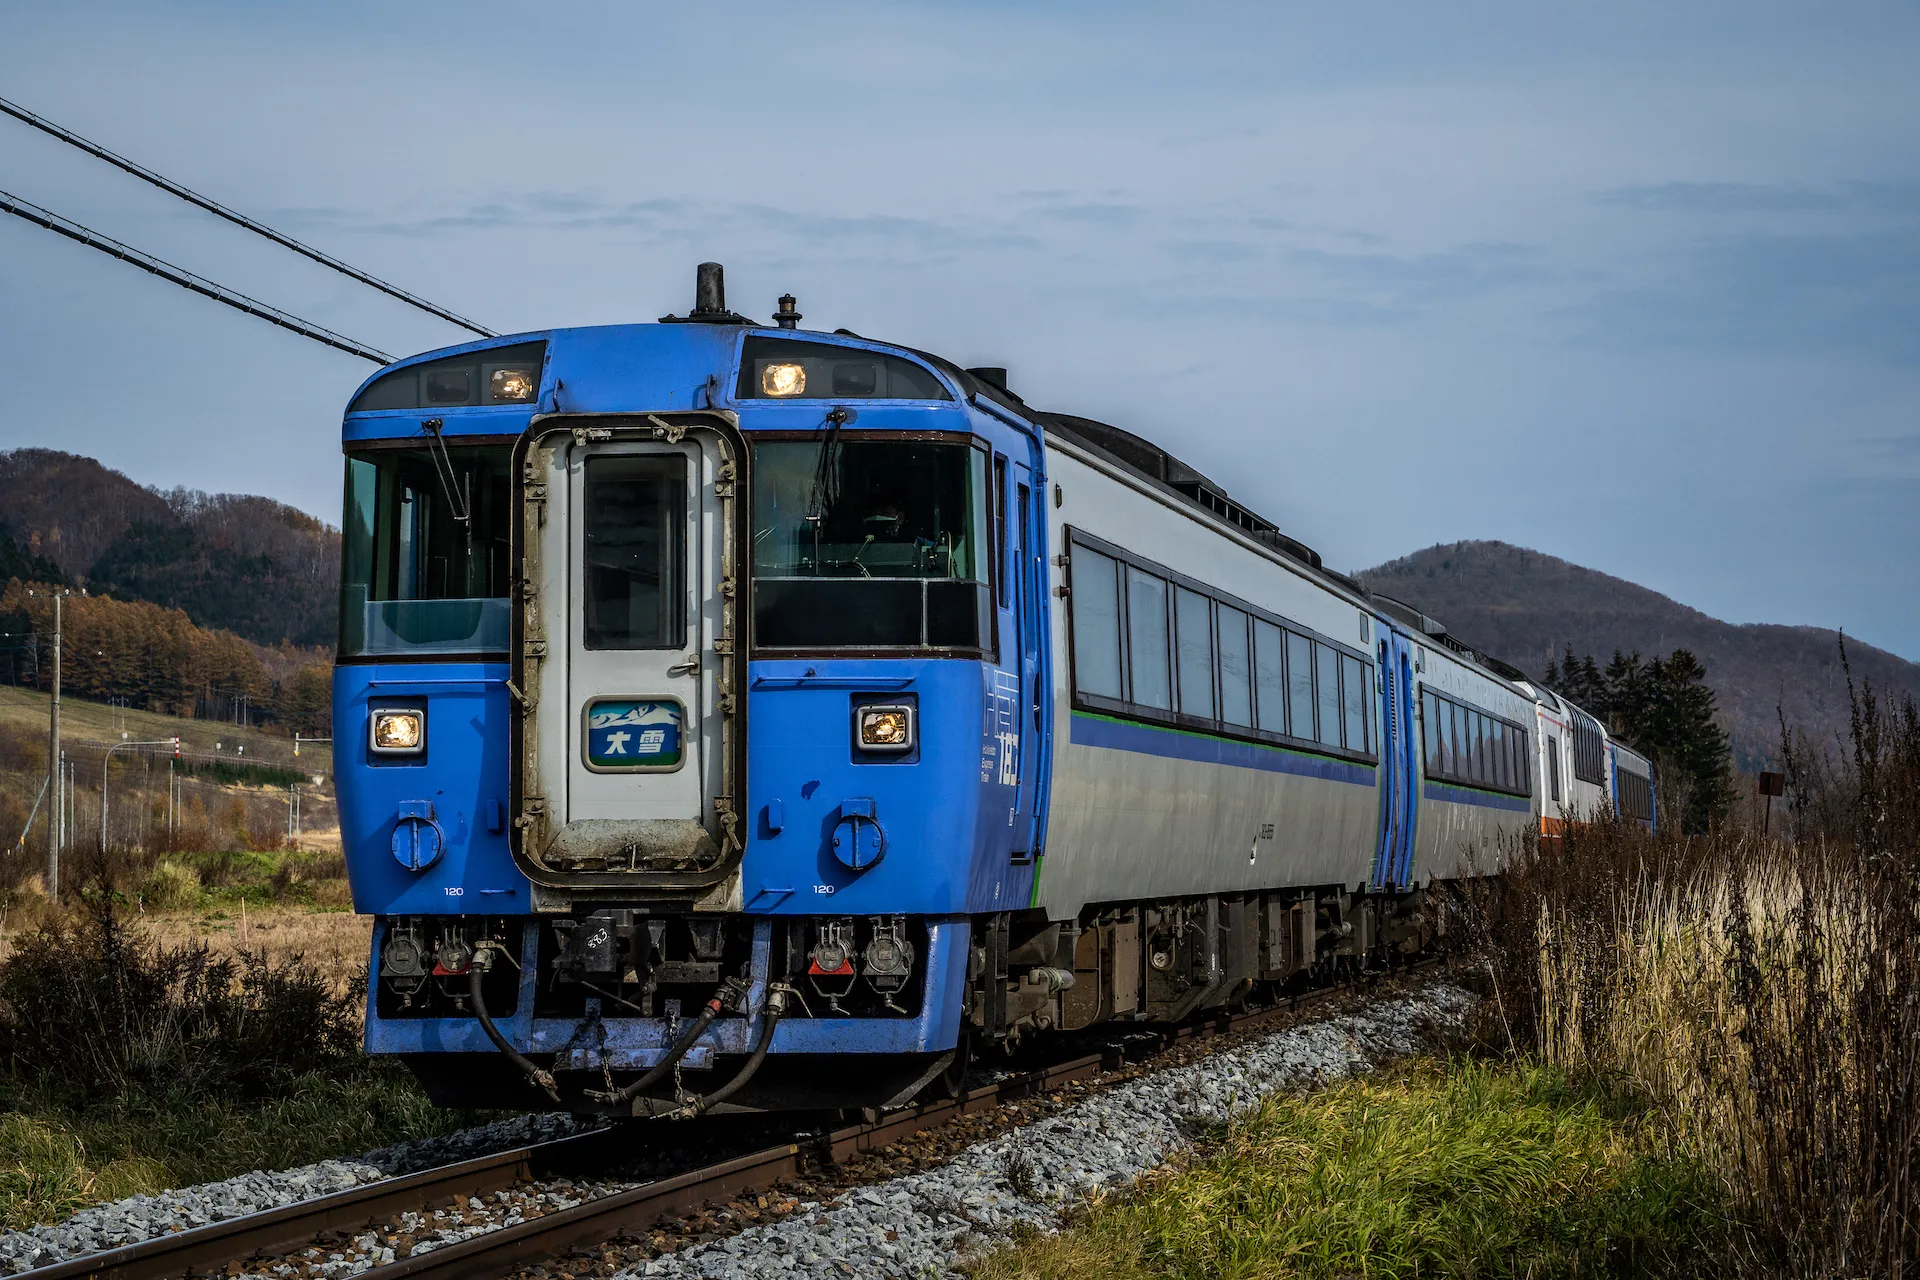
[0,687,484,1230]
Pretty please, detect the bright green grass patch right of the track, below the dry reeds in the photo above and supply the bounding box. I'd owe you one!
[973,1061,1724,1280]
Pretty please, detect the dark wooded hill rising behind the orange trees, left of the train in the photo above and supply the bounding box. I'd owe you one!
[0,449,340,647]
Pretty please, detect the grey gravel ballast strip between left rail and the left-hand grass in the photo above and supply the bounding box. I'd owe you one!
[0,1113,580,1276]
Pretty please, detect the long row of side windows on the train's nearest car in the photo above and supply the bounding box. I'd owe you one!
[1071,541,1379,754]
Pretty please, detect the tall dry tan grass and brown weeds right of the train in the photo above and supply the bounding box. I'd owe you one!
[1490,675,1920,1278]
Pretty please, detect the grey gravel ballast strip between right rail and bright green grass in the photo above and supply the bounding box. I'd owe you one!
[620,984,1473,1280]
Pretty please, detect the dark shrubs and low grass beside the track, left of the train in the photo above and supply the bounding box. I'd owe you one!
[0,889,488,1228]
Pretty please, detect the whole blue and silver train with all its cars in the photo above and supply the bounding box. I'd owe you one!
[334,265,1653,1115]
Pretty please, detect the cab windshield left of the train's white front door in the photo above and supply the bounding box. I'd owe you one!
[340,443,511,658]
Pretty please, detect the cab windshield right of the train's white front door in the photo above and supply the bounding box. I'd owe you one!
[753,436,993,652]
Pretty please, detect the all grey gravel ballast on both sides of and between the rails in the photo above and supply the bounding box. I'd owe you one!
[0,984,1471,1280]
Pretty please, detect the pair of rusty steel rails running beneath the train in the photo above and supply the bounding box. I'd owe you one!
[17,960,1444,1280]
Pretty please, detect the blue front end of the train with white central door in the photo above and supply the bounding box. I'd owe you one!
[334,285,1046,1115]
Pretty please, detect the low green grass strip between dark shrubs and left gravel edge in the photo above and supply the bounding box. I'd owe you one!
[0,1059,490,1230]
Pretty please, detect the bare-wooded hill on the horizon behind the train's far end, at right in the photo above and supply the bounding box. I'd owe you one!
[1357,541,1920,766]
